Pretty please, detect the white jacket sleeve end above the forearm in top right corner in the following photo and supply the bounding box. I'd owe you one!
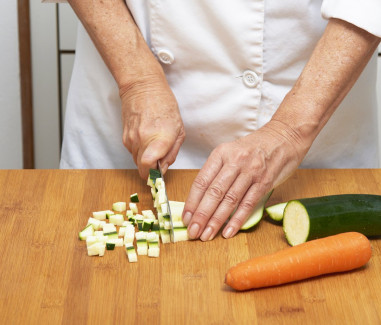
[321,0,381,37]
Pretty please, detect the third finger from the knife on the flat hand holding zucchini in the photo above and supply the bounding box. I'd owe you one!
[200,174,252,241]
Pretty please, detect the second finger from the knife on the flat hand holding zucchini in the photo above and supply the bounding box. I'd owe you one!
[188,165,239,239]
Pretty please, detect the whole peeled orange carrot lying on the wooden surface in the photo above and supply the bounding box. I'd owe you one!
[225,232,372,291]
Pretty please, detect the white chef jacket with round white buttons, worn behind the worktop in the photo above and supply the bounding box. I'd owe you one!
[60,0,381,168]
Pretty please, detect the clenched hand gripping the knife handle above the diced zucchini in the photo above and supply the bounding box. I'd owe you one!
[120,73,185,179]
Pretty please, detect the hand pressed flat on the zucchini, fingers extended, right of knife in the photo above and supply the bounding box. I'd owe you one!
[183,120,308,241]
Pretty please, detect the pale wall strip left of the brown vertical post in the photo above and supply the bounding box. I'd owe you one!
[0,1,22,169]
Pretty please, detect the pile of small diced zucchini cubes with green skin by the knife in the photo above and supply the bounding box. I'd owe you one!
[79,170,188,262]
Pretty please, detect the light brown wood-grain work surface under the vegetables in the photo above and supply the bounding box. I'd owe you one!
[0,170,381,325]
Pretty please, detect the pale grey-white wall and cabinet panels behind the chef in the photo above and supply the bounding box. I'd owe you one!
[0,4,381,169]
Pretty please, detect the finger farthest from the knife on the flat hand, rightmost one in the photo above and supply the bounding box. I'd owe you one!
[222,183,266,238]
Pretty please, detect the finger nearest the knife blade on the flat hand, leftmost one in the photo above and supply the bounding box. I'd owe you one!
[182,153,222,226]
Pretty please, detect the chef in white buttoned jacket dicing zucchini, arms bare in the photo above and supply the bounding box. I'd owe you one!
[61,0,381,240]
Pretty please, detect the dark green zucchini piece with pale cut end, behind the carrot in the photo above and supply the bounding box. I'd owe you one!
[283,194,381,246]
